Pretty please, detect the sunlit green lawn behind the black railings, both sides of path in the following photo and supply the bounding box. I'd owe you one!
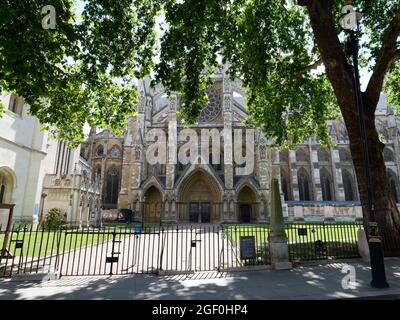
[0,223,362,258]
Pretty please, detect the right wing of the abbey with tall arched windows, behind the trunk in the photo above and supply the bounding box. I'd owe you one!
[279,94,400,220]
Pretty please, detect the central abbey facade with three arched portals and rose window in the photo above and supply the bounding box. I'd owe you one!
[82,72,279,222]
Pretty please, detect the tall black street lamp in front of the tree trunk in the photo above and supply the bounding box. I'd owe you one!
[340,1,389,288]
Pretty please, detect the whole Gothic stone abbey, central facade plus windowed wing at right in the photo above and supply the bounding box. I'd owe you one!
[82,70,400,223]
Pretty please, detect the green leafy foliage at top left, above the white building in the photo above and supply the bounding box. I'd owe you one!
[0,0,155,145]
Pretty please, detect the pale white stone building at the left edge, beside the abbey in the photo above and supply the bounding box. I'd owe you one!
[0,93,101,226]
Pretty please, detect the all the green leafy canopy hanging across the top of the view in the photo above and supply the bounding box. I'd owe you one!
[0,0,400,146]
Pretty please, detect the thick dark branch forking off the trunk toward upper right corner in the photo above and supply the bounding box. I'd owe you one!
[365,5,400,106]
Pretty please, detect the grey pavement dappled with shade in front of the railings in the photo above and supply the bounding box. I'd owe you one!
[0,258,400,300]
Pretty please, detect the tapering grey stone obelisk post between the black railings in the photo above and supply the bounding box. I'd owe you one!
[270,178,292,270]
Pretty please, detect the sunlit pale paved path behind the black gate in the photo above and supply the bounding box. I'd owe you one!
[0,225,241,276]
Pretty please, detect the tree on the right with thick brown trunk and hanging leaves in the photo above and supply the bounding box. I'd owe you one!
[149,0,400,250]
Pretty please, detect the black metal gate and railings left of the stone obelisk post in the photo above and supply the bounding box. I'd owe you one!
[0,224,270,277]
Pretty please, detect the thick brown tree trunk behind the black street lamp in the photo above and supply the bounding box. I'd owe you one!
[299,0,400,254]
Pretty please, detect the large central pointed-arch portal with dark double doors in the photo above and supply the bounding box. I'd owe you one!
[179,170,221,223]
